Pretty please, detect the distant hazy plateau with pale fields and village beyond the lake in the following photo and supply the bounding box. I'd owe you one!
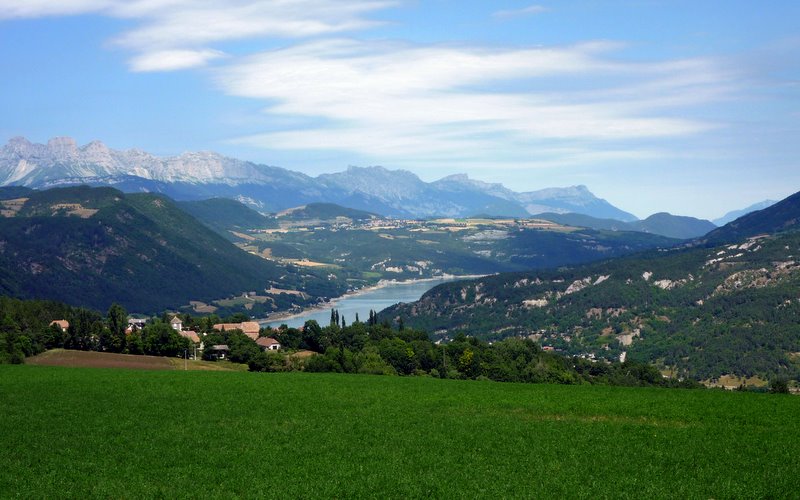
[247,219,677,279]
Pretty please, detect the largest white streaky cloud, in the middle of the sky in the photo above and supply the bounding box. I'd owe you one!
[218,39,726,165]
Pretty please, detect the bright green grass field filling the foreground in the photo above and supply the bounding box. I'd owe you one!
[0,366,800,498]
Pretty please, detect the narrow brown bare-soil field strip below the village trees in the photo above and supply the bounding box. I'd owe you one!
[25,349,242,371]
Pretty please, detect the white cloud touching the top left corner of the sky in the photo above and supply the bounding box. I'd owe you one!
[0,0,397,71]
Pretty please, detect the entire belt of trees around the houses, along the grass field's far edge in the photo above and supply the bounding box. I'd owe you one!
[0,297,697,387]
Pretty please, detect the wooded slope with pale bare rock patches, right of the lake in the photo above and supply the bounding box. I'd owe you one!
[382,232,800,379]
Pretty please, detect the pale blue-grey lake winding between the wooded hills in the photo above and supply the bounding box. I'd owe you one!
[260,276,468,328]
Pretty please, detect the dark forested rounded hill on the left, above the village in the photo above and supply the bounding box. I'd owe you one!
[0,186,330,312]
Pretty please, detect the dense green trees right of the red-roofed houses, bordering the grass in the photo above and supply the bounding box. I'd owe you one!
[252,311,698,387]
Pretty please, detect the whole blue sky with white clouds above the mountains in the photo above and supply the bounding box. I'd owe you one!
[0,0,800,219]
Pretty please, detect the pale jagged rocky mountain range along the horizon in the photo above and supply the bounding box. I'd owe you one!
[0,137,636,221]
